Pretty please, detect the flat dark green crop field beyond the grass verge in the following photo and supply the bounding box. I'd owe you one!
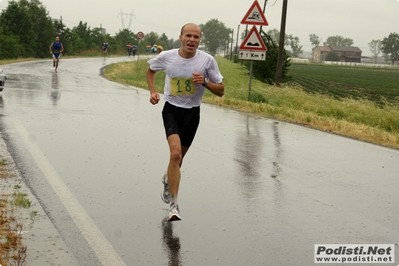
[288,63,399,104]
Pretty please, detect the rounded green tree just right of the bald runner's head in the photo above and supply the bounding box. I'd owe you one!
[200,19,231,55]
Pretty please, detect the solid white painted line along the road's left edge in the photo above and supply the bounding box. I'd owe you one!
[14,119,126,266]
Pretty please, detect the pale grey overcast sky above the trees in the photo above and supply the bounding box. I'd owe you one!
[0,0,399,56]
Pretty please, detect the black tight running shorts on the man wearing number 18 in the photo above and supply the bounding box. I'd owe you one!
[162,102,200,147]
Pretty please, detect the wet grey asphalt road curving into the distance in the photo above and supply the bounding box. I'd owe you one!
[0,58,399,265]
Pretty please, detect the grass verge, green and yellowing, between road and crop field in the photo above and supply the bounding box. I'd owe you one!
[104,58,399,149]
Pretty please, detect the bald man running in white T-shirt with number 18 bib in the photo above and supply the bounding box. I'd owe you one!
[146,23,224,221]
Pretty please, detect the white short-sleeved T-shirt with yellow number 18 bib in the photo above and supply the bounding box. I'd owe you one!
[147,49,223,108]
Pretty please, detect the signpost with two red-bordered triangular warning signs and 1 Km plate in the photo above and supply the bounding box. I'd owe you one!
[238,0,269,101]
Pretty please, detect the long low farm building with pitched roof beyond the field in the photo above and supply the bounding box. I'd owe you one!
[313,45,362,63]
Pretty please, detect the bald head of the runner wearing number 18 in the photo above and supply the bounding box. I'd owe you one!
[179,24,201,57]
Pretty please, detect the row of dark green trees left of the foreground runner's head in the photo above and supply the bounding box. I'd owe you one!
[0,0,186,59]
